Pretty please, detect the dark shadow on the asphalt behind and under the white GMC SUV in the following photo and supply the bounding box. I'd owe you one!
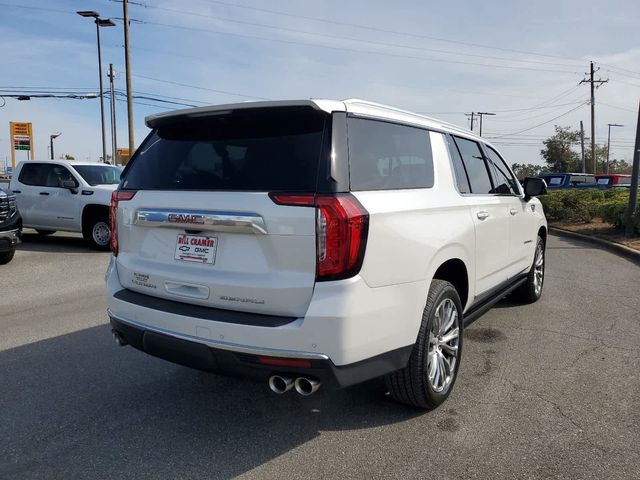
[0,325,423,479]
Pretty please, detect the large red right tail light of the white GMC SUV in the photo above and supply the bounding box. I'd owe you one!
[270,193,369,280]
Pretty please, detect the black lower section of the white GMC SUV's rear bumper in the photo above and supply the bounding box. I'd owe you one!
[108,311,413,388]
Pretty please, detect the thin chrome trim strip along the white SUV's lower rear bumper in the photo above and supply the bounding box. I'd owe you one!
[107,308,329,360]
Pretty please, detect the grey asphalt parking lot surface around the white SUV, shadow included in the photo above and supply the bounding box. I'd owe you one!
[0,234,640,479]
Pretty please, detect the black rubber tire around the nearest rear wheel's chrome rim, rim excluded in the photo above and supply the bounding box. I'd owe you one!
[386,280,464,410]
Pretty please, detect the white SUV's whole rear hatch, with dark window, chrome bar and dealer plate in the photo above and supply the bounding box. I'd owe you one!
[116,107,331,316]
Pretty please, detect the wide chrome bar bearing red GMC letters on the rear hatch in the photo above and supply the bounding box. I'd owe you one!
[134,208,267,235]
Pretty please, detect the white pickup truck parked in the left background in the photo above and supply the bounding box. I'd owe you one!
[9,160,121,250]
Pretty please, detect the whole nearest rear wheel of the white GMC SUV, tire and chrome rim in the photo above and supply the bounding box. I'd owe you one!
[386,280,463,410]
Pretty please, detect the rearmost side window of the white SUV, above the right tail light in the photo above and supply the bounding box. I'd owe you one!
[347,118,433,190]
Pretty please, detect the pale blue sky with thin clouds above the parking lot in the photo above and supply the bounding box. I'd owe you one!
[0,0,640,168]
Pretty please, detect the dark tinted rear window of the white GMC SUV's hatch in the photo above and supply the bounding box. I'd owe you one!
[123,108,329,192]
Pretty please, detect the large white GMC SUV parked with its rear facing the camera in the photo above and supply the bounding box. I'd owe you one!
[106,100,547,408]
